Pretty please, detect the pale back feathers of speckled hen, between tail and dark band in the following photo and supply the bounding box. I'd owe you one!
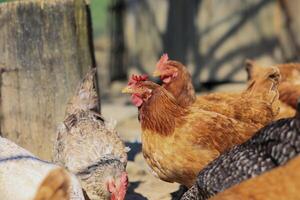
[54,113,127,173]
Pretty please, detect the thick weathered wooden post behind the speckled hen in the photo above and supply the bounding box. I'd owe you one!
[0,0,95,159]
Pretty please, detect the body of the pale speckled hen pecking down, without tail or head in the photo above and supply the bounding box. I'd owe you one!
[55,112,127,200]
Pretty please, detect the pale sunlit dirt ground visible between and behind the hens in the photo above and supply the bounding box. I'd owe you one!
[102,84,245,200]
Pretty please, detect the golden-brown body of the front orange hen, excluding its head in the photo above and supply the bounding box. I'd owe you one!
[140,90,256,187]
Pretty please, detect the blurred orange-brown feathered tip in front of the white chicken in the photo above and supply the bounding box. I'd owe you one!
[34,168,70,200]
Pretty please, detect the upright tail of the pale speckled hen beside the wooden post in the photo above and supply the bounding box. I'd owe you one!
[66,68,99,115]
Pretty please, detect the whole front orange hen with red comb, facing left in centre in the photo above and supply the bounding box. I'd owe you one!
[122,76,276,187]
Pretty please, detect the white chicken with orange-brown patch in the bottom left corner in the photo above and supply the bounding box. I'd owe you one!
[0,137,84,200]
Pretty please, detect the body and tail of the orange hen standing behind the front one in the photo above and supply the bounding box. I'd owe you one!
[196,92,295,120]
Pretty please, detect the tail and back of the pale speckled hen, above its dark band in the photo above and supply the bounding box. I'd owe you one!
[54,69,127,176]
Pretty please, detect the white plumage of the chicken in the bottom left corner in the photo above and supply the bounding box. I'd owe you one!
[0,137,84,200]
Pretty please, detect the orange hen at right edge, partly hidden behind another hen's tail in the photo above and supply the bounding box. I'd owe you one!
[247,60,300,108]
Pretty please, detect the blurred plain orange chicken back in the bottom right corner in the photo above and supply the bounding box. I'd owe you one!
[210,156,300,200]
